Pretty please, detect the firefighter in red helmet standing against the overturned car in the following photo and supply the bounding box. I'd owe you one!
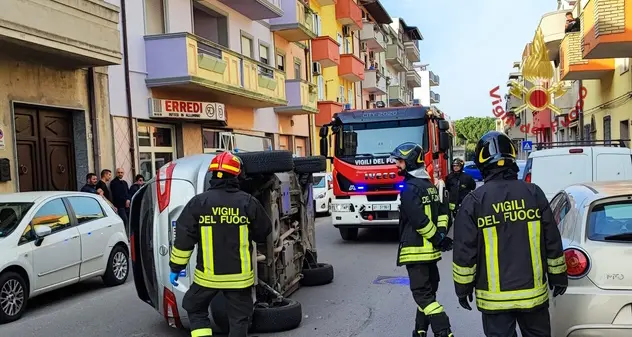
[169,152,272,337]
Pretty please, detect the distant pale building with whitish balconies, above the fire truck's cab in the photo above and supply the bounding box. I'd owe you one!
[386,18,423,107]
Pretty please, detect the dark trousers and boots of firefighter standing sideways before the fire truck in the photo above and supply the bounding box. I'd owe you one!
[406,262,450,337]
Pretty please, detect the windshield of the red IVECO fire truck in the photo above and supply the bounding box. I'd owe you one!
[336,119,426,157]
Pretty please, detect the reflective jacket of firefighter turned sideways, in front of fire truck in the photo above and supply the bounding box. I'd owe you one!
[397,175,448,266]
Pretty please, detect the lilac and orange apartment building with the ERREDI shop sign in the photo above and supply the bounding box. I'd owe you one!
[110,0,315,179]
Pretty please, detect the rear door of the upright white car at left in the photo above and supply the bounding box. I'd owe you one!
[66,196,113,278]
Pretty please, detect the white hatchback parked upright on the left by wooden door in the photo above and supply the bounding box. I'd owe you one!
[0,192,129,324]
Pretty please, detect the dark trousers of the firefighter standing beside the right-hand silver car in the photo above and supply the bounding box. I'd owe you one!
[483,307,551,337]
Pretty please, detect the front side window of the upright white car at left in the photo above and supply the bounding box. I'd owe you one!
[20,198,72,243]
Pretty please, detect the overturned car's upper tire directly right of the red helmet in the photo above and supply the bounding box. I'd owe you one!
[235,150,294,174]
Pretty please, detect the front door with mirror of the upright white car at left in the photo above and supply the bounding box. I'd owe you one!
[25,198,81,290]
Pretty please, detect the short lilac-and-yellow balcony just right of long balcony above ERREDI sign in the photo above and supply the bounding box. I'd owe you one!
[274,80,318,115]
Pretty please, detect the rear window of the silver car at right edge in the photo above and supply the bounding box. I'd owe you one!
[588,200,632,241]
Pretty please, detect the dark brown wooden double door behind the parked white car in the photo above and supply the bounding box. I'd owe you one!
[15,109,77,192]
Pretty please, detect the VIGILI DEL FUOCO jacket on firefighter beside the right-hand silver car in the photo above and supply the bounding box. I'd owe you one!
[452,173,568,313]
